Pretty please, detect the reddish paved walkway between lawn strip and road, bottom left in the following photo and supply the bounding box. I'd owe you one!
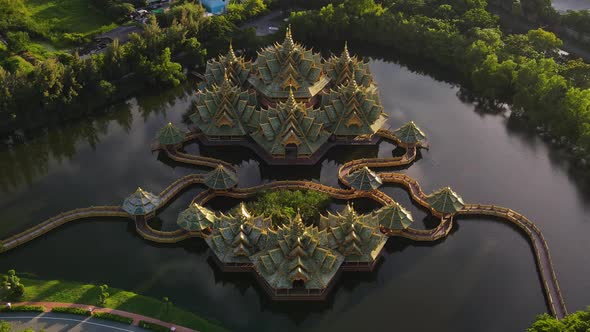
[0,302,195,332]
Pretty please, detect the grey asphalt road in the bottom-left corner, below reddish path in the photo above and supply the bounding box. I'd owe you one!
[0,312,146,332]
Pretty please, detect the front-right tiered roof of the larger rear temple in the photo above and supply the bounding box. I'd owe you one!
[322,76,383,136]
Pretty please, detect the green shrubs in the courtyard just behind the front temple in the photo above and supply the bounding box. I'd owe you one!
[246,190,331,225]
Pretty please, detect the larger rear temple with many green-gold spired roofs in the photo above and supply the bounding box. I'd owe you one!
[190,28,385,163]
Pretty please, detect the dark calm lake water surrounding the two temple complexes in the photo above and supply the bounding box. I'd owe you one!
[0,61,590,332]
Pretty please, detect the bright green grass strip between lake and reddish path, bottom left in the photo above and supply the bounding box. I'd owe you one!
[21,278,227,332]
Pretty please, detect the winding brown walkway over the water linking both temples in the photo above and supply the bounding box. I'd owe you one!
[0,130,567,319]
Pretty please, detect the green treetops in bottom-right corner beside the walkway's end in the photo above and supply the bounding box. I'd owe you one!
[527,307,590,332]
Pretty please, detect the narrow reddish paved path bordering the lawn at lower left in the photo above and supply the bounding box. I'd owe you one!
[1,302,195,332]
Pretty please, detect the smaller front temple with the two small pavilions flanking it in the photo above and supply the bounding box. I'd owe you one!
[177,203,413,300]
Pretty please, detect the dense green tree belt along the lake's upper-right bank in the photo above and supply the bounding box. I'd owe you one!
[290,0,590,159]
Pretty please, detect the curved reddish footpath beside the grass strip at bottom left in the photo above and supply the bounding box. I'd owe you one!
[0,302,195,332]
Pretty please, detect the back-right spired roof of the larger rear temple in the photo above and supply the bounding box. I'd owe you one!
[324,44,373,87]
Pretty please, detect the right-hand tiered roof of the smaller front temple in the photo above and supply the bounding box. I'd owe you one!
[320,205,387,263]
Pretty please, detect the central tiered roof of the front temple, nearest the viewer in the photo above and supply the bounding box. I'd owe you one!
[251,214,344,290]
